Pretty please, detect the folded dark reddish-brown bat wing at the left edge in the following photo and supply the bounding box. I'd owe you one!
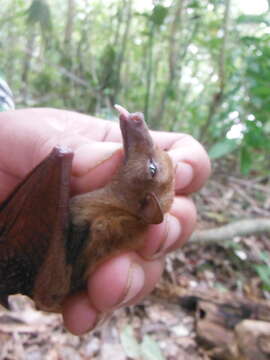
[0,147,73,308]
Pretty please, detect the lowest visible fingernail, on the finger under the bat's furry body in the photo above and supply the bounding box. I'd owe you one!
[117,262,145,306]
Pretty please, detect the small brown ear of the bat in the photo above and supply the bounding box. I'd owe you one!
[140,192,163,224]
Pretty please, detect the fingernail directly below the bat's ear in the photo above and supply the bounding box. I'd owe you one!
[151,214,181,260]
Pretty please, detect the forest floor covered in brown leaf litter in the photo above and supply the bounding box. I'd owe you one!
[0,164,270,360]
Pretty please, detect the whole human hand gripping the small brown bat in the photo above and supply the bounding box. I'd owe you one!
[0,109,210,335]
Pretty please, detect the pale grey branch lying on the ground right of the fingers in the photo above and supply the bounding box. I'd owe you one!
[189,218,270,243]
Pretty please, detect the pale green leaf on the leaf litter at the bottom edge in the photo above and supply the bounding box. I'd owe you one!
[120,325,165,360]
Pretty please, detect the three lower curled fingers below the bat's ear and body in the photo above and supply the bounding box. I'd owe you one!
[63,196,196,334]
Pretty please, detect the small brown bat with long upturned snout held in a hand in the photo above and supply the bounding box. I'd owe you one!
[0,105,174,312]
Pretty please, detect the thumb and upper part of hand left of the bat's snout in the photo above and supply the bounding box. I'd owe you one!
[0,109,122,201]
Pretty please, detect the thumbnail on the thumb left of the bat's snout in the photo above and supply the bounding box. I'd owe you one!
[72,141,122,176]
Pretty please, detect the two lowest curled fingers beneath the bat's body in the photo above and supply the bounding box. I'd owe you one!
[63,252,163,335]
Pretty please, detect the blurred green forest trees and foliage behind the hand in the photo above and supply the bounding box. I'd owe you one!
[0,0,270,175]
